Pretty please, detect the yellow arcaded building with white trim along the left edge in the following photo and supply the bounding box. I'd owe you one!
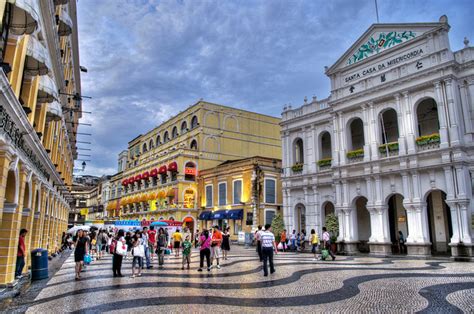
[0,0,82,285]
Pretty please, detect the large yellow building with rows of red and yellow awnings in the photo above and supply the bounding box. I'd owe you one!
[116,101,281,233]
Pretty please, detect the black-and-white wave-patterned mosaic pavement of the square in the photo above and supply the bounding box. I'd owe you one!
[27,246,474,313]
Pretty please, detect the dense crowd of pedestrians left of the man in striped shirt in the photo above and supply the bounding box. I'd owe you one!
[68,226,230,280]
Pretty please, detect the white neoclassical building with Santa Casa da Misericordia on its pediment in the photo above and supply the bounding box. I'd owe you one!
[281,16,474,258]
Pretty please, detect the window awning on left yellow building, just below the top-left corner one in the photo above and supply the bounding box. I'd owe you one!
[25,36,52,76]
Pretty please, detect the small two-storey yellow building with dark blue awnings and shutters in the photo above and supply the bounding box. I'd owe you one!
[198,157,283,240]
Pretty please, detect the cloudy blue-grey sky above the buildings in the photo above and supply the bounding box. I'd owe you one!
[75,0,474,176]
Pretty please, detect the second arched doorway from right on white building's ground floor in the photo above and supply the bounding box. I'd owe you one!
[388,194,408,254]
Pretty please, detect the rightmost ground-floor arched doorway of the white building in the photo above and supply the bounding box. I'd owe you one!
[426,190,453,255]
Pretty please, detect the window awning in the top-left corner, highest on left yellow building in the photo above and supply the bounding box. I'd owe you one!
[8,0,40,36]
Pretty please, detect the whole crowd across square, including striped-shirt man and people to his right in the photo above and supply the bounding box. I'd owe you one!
[68,224,336,280]
